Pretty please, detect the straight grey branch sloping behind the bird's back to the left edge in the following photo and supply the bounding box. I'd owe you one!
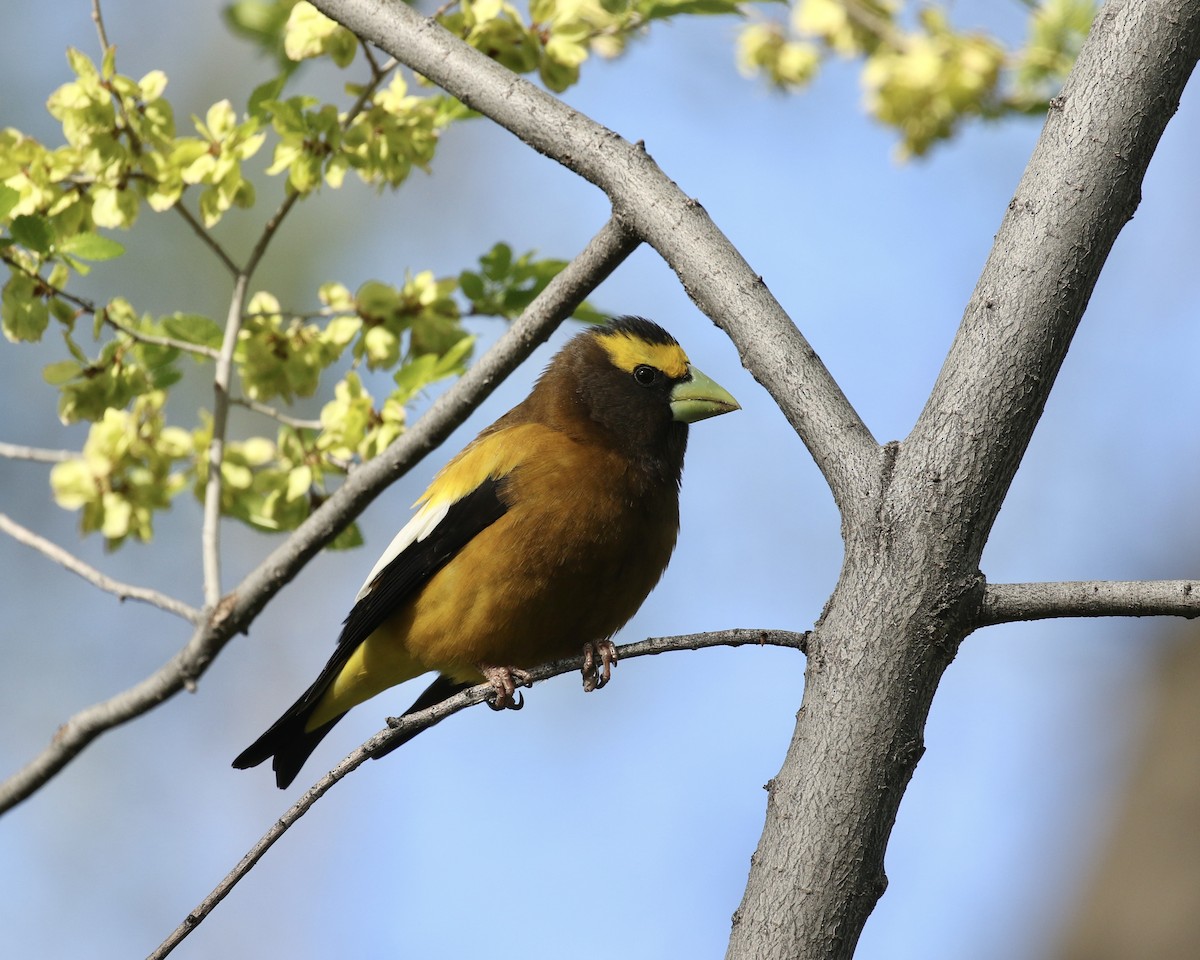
[0,218,638,812]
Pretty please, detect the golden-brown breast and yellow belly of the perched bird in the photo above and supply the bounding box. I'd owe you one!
[307,432,678,730]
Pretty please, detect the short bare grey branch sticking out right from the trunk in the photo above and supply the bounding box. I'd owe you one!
[979,580,1200,626]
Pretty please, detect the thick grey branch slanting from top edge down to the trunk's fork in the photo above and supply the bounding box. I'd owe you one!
[314,0,878,525]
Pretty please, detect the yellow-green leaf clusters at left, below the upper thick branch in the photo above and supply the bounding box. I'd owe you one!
[0,0,609,547]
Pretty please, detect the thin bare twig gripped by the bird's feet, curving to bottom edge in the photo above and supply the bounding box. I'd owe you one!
[148,630,808,960]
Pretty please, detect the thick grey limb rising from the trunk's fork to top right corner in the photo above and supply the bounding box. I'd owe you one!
[895,0,1200,560]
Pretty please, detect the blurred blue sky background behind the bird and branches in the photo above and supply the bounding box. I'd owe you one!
[0,0,1200,960]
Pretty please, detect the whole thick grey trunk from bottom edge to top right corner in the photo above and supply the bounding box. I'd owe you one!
[727,0,1200,960]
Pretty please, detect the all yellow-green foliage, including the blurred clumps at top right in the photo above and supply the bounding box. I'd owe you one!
[0,0,1094,546]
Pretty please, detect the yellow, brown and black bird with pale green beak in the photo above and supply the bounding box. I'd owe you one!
[233,317,738,788]
